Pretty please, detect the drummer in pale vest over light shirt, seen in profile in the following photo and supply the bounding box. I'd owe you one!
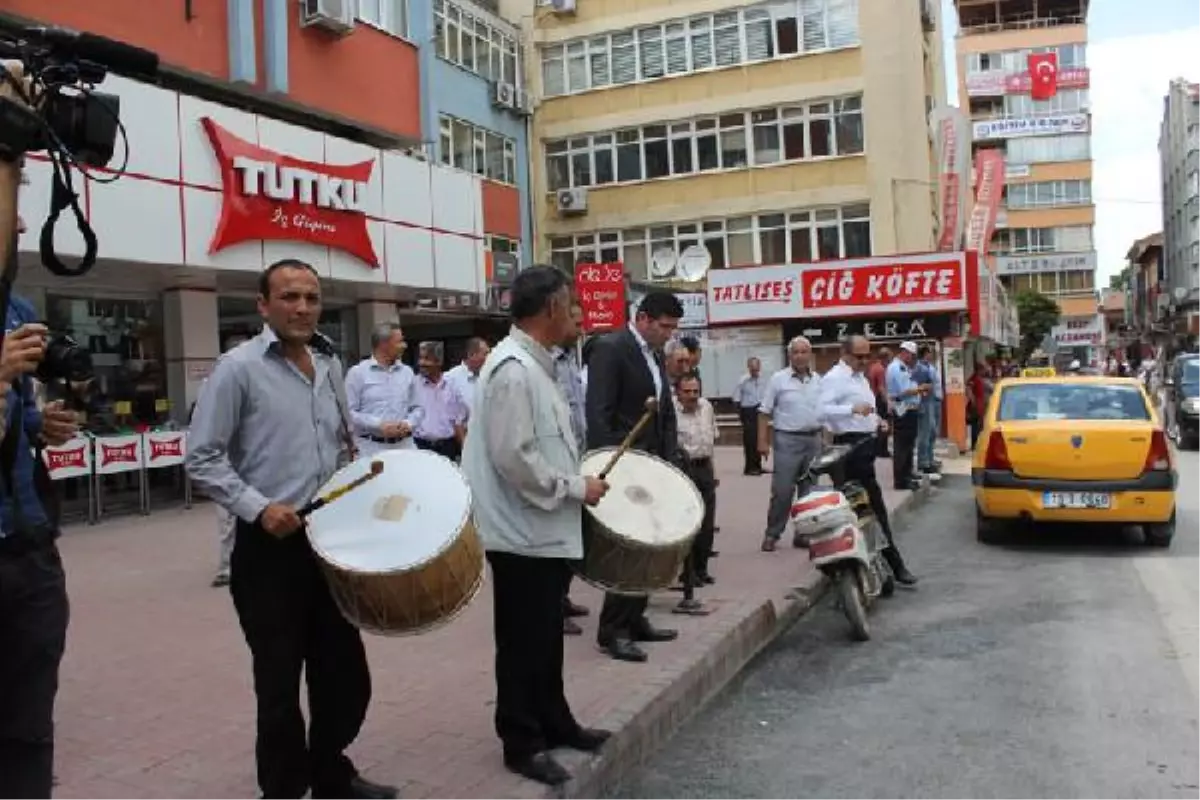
[462,266,610,786]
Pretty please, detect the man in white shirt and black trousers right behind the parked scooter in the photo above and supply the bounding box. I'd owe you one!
[821,336,917,587]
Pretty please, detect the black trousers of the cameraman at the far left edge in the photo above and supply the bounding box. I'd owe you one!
[0,536,71,800]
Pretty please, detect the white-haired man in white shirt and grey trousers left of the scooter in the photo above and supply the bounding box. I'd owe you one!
[758,336,824,553]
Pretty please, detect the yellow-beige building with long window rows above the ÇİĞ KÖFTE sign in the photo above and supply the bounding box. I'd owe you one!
[516,0,943,281]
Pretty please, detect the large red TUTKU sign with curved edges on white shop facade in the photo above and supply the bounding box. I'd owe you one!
[200,118,379,267]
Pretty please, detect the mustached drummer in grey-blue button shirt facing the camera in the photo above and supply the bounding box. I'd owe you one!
[187,259,396,800]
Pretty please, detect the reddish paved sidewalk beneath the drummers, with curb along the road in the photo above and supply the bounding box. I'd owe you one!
[55,447,919,800]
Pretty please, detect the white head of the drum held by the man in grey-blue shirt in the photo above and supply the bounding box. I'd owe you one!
[308,450,470,575]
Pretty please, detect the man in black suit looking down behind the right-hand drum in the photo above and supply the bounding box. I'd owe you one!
[587,291,683,662]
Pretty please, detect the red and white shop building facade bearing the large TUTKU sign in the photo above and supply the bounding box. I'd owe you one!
[7,0,526,422]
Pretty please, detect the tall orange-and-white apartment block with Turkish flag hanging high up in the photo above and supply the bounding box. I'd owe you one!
[954,0,1097,318]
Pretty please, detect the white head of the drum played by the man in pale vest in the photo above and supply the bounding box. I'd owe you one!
[582,447,704,546]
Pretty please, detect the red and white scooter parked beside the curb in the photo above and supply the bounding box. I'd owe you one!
[792,437,896,642]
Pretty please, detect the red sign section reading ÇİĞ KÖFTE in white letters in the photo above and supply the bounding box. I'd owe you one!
[800,258,965,309]
